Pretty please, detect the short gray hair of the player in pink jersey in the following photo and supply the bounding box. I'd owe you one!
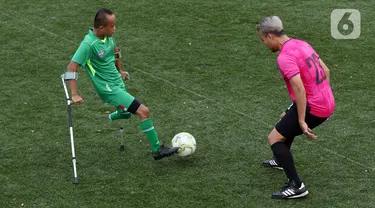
[256,16,284,36]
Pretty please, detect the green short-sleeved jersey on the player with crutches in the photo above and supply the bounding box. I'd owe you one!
[72,29,124,101]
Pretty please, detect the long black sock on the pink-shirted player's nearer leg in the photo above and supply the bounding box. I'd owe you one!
[271,142,301,188]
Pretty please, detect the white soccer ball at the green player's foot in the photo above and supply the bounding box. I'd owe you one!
[172,132,197,157]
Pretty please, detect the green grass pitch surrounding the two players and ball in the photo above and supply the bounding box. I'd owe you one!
[0,0,375,207]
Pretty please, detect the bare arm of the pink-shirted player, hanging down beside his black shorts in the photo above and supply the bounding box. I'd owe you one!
[290,74,316,140]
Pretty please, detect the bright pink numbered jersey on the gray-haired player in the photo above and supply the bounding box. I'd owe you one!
[277,39,335,118]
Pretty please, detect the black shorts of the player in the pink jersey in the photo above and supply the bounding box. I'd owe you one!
[275,103,327,139]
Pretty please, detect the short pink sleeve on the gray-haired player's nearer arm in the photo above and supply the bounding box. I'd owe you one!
[277,55,300,80]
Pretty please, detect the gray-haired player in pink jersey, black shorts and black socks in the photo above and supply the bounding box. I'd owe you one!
[256,16,335,199]
